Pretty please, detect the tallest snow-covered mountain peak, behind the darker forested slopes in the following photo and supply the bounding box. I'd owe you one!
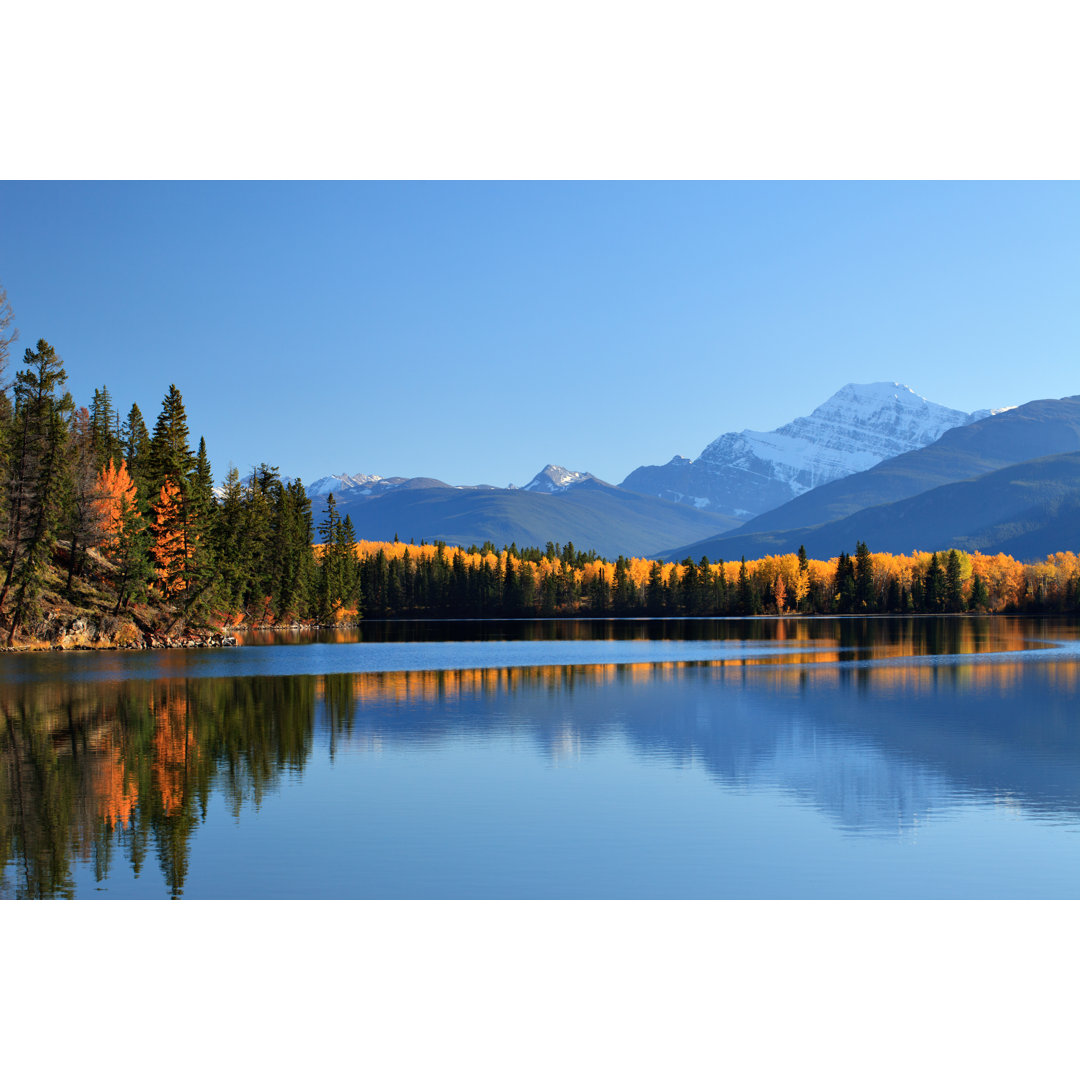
[620,382,1001,519]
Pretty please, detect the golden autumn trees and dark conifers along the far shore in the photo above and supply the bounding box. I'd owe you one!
[315,540,1080,617]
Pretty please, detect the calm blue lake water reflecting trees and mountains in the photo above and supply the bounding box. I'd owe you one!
[0,618,1080,899]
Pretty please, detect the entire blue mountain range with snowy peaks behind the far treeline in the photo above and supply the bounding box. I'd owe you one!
[291,382,1080,559]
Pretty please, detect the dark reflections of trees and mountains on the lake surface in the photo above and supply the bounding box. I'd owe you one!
[6,620,1080,897]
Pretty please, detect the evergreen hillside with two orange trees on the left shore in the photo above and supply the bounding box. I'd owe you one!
[0,293,332,645]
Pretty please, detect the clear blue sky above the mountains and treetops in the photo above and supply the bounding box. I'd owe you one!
[0,181,1080,485]
